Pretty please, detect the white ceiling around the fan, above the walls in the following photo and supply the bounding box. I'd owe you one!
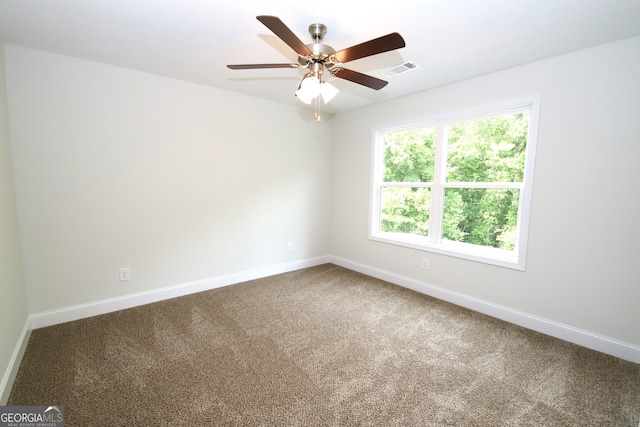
[0,0,640,113]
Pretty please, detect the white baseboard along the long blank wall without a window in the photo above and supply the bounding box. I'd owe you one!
[29,256,331,329]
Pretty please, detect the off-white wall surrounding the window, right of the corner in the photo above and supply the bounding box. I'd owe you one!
[331,38,640,346]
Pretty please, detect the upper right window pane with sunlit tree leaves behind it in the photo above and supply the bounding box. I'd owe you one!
[447,112,529,182]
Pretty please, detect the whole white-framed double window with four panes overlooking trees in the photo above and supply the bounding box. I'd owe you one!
[369,98,539,270]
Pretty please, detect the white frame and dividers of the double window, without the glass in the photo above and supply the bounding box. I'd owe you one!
[369,95,540,271]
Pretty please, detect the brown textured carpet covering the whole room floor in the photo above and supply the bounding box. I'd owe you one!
[9,264,640,427]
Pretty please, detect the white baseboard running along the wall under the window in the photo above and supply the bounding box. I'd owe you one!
[331,256,640,364]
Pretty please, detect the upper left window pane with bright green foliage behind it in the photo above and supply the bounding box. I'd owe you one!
[383,127,436,182]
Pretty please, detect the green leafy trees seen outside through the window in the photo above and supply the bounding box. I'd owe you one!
[380,112,530,250]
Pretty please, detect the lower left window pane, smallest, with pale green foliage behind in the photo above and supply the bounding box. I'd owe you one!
[380,187,431,236]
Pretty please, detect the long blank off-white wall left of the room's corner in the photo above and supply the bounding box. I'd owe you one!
[6,45,330,314]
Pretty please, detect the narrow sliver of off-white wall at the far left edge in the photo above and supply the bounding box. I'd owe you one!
[0,40,27,404]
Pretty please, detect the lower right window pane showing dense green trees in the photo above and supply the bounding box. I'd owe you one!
[442,188,520,250]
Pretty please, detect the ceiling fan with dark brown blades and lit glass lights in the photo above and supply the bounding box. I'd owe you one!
[227,15,405,121]
